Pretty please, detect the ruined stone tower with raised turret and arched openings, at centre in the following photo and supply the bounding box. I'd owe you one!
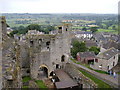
[27,25,70,79]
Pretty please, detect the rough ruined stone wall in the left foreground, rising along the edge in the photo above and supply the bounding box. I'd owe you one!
[1,17,21,88]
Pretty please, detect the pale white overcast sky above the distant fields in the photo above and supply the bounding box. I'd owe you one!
[0,0,120,14]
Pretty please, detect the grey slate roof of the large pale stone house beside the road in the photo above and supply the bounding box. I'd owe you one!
[97,48,118,60]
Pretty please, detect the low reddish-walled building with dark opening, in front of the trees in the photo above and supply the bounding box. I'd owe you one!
[77,51,97,64]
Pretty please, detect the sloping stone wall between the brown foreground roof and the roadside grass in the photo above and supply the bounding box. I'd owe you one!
[64,63,97,89]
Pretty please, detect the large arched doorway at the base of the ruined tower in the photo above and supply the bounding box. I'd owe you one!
[38,65,48,79]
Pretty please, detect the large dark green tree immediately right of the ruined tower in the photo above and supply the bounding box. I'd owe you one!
[71,40,87,58]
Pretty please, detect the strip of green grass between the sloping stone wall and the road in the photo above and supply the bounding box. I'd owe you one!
[80,70,111,88]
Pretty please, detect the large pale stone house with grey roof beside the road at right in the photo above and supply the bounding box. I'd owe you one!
[91,48,118,71]
